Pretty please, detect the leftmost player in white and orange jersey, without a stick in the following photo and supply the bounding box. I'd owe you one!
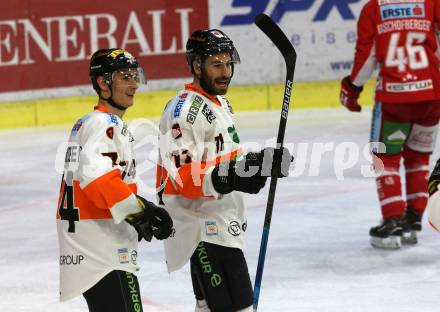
[56,49,172,312]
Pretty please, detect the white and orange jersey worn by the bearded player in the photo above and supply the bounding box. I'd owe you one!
[157,84,247,272]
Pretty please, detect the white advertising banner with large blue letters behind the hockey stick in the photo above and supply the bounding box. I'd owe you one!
[210,0,367,84]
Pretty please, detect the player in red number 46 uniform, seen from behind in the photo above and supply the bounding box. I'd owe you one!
[340,0,440,249]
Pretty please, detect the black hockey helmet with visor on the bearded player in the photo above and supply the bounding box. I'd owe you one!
[186,29,240,74]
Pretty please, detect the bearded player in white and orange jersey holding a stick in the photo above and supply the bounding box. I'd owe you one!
[157,29,291,312]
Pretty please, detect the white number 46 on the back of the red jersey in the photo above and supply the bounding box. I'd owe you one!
[385,31,429,72]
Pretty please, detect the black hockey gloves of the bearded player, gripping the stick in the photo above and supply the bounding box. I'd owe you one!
[211,147,293,194]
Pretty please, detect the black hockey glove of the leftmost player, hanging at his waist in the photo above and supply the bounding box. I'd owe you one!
[125,195,173,242]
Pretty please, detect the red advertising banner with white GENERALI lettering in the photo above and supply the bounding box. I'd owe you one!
[0,0,209,92]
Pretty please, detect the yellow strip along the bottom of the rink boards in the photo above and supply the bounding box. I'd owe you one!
[0,81,374,129]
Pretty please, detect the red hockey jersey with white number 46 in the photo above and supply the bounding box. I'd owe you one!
[351,0,440,103]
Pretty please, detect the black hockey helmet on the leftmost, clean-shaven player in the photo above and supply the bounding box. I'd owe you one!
[89,49,145,94]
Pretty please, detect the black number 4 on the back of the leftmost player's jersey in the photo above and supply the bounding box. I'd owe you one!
[58,172,79,233]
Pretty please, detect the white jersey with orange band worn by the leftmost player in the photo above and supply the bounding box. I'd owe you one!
[56,106,141,301]
